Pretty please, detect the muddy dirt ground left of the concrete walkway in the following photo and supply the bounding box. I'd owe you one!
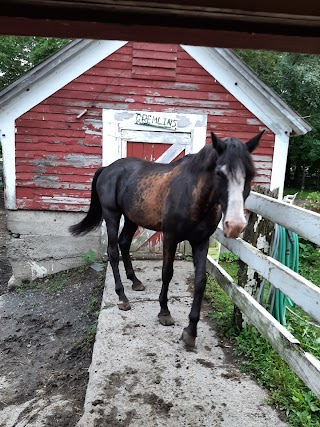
[0,192,104,427]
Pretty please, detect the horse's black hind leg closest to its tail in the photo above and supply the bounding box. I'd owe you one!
[103,211,131,310]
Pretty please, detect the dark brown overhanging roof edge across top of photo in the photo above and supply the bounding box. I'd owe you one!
[0,0,320,53]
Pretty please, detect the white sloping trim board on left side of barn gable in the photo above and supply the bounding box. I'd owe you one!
[0,40,127,119]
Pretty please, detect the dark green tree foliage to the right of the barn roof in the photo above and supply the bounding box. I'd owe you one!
[236,50,320,188]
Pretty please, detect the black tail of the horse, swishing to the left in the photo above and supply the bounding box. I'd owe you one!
[69,167,104,236]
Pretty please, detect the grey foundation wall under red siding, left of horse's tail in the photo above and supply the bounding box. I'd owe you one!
[6,210,103,287]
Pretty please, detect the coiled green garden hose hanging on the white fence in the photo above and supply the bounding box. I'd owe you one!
[257,224,299,326]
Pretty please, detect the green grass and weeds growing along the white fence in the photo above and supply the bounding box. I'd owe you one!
[206,251,320,427]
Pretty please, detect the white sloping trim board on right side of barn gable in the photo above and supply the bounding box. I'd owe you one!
[181,45,292,136]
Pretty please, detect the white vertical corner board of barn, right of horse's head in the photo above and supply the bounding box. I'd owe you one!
[270,135,289,199]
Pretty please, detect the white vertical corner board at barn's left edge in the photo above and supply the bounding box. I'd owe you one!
[0,120,16,209]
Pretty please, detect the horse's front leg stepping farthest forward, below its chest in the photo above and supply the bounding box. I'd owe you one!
[181,239,209,348]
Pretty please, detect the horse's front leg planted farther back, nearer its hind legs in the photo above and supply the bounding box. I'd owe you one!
[158,233,177,326]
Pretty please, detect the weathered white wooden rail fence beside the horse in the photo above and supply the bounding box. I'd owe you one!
[207,192,320,399]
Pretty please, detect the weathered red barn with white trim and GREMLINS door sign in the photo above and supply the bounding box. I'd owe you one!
[0,40,310,288]
